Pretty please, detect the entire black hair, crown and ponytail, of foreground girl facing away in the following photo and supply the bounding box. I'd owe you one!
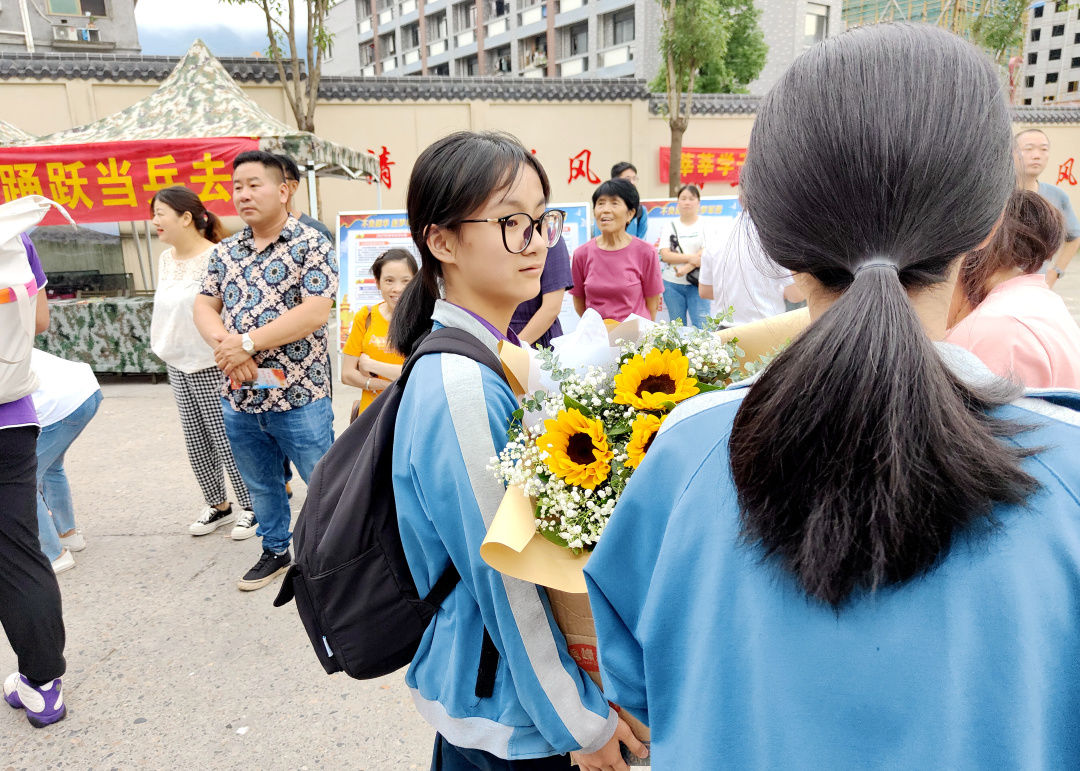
[729,24,1036,608]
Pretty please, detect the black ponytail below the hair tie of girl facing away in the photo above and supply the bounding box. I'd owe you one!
[729,263,1035,606]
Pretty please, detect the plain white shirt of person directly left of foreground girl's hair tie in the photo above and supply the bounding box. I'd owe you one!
[698,213,801,326]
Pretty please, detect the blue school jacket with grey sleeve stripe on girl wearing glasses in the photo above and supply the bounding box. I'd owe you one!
[393,301,618,759]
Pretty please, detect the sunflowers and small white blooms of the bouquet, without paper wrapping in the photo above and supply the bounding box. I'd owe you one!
[491,313,741,554]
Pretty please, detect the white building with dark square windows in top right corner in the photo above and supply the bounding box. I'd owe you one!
[1015,2,1080,106]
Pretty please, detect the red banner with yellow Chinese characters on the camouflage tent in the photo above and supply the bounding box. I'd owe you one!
[0,137,259,225]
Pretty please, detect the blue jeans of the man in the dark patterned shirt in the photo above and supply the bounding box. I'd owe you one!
[221,398,334,554]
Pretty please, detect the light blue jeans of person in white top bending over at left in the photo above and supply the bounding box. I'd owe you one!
[38,391,102,562]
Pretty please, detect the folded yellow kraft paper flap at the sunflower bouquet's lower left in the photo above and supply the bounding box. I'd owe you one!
[480,485,589,594]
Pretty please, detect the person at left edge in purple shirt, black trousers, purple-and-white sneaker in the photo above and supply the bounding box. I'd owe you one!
[0,235,67,728]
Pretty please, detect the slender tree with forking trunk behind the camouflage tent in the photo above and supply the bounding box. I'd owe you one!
[220,0,333,132]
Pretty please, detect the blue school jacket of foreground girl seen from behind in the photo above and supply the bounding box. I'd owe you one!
[585,346,1080,770]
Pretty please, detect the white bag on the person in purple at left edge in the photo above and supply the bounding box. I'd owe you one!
[0,195,75,404]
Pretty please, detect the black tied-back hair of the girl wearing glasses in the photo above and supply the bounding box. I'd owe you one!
[390,131,551,356]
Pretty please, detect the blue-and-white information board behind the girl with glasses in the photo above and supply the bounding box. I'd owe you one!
[337,203,592,350]
